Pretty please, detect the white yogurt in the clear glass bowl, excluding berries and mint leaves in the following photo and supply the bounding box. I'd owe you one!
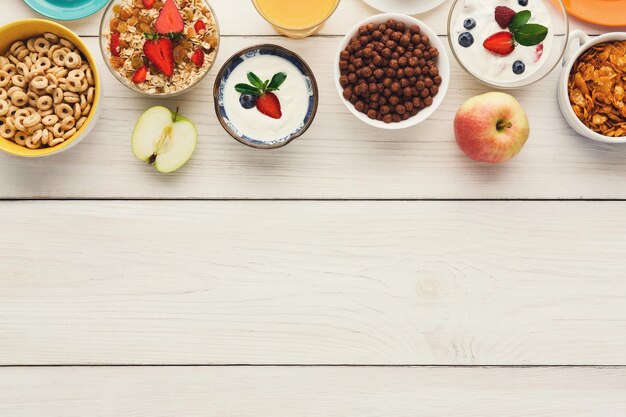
[452,0,553,84]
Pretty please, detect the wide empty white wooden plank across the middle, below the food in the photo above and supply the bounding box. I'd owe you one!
[0,201,626,365]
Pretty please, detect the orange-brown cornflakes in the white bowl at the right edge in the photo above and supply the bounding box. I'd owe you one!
[568,41,626,137]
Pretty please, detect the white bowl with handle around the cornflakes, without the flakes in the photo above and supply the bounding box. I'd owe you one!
[557,30,626,143]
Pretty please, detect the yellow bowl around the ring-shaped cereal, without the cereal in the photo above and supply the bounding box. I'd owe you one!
[0,19,101,157]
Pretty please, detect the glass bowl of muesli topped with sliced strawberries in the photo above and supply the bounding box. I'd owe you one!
[100,0,220,96]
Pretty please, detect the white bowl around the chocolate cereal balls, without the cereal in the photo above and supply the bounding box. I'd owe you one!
[334,13,450,130]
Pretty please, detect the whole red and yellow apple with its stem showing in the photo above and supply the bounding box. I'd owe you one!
[454,92,530,163]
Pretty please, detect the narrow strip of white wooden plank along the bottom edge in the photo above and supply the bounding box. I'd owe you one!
[0,367,626,417]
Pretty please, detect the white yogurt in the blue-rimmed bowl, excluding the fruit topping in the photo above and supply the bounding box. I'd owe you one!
[223,55,310,142]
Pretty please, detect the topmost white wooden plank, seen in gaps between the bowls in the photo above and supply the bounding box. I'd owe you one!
[0,0,608,36]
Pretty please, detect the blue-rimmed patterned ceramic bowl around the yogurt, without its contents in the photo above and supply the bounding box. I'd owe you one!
[213,44,319,149]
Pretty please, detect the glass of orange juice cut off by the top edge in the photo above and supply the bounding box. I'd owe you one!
[252,0,339,38]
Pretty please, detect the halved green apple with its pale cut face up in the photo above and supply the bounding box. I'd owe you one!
[131,106,198,173]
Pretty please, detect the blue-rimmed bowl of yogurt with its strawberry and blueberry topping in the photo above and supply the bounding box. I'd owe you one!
[213,44,319,149]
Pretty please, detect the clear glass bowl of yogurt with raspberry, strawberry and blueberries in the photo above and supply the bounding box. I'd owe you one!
[448,0,569,89]
